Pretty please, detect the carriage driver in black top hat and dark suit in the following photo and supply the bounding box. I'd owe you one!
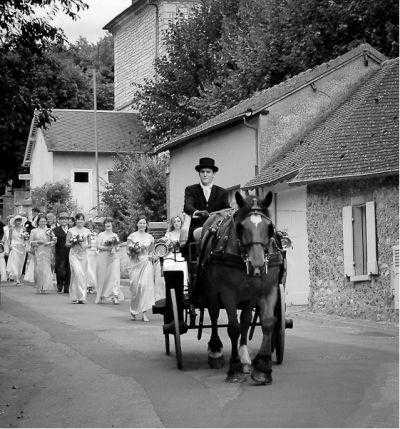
[183,158,230,243]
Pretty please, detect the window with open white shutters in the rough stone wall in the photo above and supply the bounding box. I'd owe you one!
[343,201,378,281]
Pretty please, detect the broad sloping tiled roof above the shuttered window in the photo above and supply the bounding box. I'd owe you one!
[245,58,399,188]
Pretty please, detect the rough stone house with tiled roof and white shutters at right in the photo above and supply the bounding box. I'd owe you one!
[245,58,399,320]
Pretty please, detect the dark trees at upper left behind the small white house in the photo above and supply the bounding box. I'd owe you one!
[0,0,113,194]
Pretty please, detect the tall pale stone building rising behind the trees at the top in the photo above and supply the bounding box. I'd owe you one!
[103,0,196,110]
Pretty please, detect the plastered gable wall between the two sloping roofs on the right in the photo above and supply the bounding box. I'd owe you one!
[260,57,379,165]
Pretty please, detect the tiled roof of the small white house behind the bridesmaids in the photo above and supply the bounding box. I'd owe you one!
[24,109,143,165]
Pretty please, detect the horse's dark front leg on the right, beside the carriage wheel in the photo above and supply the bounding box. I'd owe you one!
[251,287,278,385]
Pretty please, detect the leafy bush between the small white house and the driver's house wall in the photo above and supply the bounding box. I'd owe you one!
[102,155,168,238]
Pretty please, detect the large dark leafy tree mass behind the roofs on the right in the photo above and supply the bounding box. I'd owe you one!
[135,0,398,146]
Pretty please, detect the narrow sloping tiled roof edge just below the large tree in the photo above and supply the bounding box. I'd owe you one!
[156,43,386,152]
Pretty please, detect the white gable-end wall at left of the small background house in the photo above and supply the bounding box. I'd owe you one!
[29,129,53,188]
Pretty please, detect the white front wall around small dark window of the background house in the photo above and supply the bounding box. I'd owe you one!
[54,152,114,212]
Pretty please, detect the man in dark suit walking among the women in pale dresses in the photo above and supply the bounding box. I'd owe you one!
[53,212,71,293]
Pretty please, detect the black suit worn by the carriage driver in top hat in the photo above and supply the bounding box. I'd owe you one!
[183,184,230,242]
